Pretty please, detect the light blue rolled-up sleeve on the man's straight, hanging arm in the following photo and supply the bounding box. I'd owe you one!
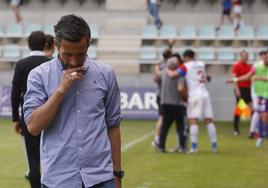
[105,70,122,128]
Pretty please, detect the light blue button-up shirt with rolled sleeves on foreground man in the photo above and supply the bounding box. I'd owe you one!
[23,58,122,188]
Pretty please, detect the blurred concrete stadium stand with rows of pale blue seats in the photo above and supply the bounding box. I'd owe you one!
[0,0,268,70]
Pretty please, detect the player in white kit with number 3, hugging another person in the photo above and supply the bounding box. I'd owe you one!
[167,50,217,153]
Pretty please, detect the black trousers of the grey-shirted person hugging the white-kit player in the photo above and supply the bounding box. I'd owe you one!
[159,104,186,149]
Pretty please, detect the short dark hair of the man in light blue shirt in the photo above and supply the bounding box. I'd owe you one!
[54,14,91,42]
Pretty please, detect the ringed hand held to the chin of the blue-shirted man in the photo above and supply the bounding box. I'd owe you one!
[59,67,83,93]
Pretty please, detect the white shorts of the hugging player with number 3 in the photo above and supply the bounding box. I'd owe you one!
[187,93,213,119]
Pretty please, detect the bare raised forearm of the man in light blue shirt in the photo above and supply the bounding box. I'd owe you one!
[28,88,64,135]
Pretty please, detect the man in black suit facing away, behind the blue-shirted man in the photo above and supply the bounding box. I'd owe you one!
[11,31,49,188]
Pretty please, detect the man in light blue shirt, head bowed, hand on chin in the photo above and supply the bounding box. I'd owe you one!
[23,15,123,188]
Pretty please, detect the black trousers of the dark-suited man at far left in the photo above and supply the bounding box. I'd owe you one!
[21,116,41,188]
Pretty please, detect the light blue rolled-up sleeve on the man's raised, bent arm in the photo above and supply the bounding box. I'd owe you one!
[23,69,48,124]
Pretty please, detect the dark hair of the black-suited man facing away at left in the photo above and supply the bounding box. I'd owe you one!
[28,31,46,51]
